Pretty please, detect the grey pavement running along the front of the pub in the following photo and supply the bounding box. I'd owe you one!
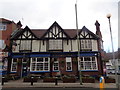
[1,79,116,88]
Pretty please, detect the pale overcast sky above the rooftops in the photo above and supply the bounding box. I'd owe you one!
[0,0,119,51]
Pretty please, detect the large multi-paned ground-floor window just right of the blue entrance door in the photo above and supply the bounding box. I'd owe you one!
[31,58,50,71]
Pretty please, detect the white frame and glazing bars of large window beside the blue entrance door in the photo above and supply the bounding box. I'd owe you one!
[30,57,50,71]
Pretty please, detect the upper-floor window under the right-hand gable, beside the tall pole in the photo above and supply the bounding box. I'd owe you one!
[81,40,92,50]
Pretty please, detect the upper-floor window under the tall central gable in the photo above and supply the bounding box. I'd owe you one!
[49,40,62,50]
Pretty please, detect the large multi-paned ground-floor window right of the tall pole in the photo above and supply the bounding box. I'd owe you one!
[79,57,98,70]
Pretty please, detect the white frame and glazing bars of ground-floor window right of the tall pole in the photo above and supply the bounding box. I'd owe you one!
[78,57,98,70]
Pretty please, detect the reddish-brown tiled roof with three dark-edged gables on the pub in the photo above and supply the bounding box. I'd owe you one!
[11,21,99,39]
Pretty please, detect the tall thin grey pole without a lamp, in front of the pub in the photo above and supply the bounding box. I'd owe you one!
[75,0,82,85]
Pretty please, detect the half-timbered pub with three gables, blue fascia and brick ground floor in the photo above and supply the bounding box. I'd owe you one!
[8,21,103,77]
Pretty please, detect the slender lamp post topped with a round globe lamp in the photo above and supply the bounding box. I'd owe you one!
[106,14,119,88]
